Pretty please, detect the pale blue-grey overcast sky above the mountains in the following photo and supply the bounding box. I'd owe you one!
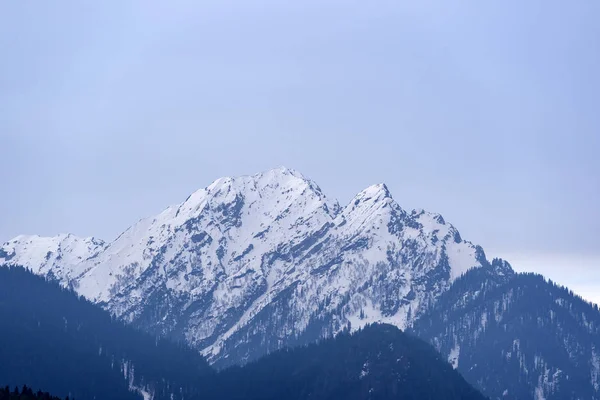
[0,0,600,302]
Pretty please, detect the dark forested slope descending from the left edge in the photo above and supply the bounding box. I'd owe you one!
[0,267,213,400]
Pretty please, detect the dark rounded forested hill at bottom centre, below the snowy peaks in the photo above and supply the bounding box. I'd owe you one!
[204,325,484,400]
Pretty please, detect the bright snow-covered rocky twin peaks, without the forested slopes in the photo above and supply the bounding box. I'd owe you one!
[0,168,488,364]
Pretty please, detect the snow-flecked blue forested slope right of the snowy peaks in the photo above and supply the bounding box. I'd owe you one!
[412,261,600,400]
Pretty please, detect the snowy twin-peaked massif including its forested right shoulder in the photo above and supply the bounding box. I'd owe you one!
[0,168,600,400]
